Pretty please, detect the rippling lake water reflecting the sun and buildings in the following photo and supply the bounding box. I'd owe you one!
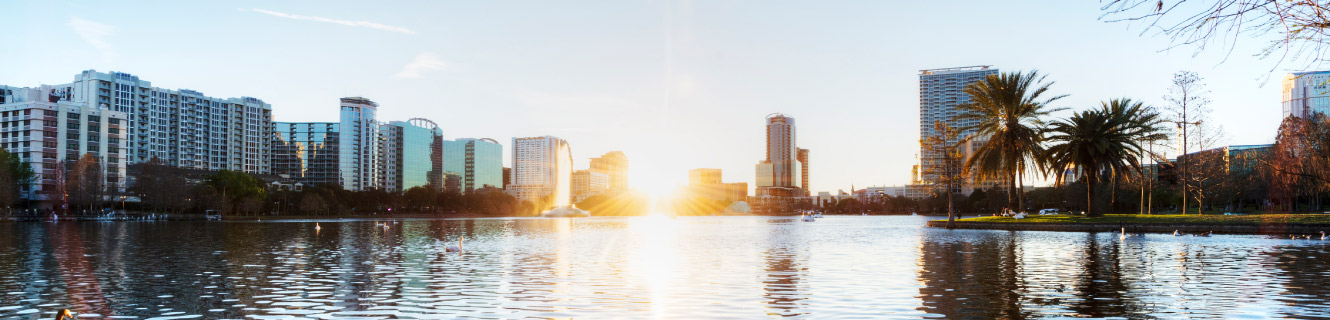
[0,216,1330,319]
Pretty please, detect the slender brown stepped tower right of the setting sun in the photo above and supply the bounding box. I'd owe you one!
[757,113,803,197]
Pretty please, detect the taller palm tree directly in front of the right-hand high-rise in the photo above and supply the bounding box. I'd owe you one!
[956,70,1067,210]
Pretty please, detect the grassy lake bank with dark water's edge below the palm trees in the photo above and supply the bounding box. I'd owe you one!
[924,214,1330,236]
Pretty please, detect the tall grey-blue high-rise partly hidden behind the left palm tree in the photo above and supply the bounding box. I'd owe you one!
[919,65,998,193]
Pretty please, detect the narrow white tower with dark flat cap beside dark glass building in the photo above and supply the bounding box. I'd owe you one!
[338,97,379,191]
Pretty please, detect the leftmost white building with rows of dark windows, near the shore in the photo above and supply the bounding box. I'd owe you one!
[0,85,129,204]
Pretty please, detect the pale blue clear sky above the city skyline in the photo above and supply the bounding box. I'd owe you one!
[0,0,1307,194]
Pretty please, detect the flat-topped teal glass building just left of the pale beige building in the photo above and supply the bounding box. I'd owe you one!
[443,138,504,193]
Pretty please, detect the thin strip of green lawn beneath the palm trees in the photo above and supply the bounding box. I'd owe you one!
[958,214,1330,224]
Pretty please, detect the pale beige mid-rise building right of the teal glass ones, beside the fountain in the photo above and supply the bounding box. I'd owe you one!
[505,135,573,210]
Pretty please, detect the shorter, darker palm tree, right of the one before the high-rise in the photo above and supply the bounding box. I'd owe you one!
[1041,98,1164,216]
